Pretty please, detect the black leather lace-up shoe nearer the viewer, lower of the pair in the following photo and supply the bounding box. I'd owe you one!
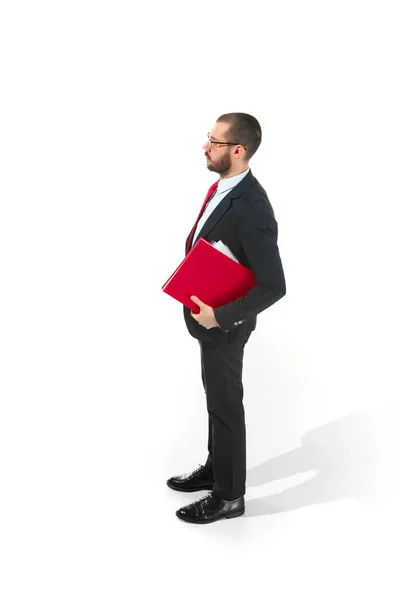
[175,493,244,523]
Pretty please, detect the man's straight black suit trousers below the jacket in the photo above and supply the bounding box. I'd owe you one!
[198,330,253,500]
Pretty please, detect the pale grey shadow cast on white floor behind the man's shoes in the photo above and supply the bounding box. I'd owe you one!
[245,409,400,517]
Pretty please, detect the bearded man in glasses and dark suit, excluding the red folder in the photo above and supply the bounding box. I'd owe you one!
[167,113,286,523]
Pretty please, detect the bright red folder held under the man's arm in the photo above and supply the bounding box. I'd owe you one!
[162,238,257,314]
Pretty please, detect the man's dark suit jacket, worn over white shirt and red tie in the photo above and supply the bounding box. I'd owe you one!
[183,169,286,341]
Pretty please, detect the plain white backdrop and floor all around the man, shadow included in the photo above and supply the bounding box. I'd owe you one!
[0,0,400,600]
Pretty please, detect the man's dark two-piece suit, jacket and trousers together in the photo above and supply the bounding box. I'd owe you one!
[183,169,286,500]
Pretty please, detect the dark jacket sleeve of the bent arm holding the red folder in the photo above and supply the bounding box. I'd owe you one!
[214,200,286,331]
